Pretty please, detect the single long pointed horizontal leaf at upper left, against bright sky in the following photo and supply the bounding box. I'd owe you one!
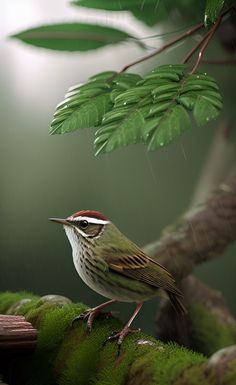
[11,23,140,51]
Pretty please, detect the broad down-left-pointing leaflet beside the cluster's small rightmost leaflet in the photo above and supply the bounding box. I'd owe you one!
[147,105,191,151]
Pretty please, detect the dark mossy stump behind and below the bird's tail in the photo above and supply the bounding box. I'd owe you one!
[156,275,236,356]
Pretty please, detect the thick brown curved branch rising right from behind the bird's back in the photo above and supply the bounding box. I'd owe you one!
[144,169,236,280]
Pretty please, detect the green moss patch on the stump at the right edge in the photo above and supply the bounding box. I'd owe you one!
[189,304,236,356]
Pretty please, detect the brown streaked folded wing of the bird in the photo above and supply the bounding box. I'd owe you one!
[104,249,182,295]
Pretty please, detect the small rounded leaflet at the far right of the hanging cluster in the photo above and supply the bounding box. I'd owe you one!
[193,95,219,126]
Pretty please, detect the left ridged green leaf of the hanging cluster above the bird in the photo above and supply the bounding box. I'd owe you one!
[49,71,141,134]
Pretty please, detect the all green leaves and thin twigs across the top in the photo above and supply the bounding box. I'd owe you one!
[9,0,232,155]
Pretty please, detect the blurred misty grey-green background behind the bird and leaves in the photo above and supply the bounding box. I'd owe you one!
[0,0,236,332]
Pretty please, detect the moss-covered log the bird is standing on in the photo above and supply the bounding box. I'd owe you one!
[0,292,236,385]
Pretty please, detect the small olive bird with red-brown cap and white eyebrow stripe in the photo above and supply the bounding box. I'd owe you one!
[50,210,186,346]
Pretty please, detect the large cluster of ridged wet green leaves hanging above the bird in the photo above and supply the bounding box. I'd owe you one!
[50,65,222,154]
